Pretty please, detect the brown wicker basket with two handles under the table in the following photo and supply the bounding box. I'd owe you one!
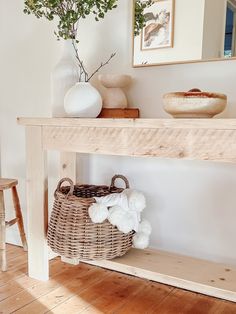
[48,175,134,260]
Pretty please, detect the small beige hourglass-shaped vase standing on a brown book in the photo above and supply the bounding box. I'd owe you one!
[98,74,132,109]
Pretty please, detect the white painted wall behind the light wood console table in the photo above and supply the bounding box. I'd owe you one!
[0,0,236,265]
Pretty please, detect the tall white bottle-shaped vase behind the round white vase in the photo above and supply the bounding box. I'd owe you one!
[51,40,79,117]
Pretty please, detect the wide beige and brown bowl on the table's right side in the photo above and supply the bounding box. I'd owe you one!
[163,89,227,118]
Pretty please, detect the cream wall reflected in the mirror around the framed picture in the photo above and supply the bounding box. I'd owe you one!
[134,0,206,65]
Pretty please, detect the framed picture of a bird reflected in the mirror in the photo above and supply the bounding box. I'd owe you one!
[141,0,174,50]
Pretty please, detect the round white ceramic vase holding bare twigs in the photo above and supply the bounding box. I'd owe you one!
[64,82,102,118]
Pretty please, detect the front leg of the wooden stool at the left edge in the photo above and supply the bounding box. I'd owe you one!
[0,191,7,271]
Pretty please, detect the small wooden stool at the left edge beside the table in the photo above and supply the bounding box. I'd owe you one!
[0,178,27,271]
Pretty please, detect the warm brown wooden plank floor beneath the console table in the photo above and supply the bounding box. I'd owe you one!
[0,245,236,314]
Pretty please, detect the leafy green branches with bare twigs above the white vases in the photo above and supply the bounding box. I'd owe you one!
[24,0,118,81]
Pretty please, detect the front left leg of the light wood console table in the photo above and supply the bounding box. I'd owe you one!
[26,126,49,280]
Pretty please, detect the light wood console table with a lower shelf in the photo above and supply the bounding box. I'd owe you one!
[18,118,236,302]
